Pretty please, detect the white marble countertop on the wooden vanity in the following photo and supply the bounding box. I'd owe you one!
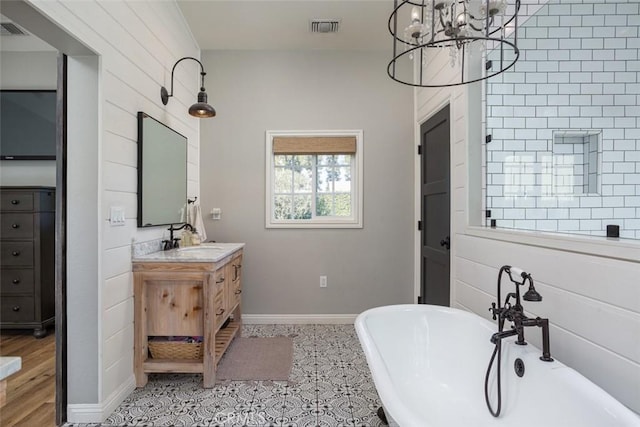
[132,243,244,262]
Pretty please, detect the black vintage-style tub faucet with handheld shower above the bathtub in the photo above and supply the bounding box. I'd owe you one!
[489,265,553,362]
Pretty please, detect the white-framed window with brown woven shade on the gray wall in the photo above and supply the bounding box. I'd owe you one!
[266,130,362,228]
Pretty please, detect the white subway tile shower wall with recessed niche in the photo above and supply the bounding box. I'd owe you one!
[485,0,640,239]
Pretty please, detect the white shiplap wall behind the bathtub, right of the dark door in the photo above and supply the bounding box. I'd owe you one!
[415,1,640,412]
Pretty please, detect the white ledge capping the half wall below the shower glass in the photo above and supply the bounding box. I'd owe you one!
[463,226,640,263]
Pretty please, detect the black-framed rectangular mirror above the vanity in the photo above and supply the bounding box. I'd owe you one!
[138,111,187,227]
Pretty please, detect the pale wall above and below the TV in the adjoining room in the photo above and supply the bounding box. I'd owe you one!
[0,50,58,187]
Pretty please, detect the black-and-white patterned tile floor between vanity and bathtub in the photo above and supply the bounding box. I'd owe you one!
[67,325,383,427]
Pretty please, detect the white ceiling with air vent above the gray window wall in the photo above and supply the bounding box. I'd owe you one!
[178,0,393,51]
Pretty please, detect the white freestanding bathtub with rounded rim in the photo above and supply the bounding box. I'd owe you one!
[355,305,640,427]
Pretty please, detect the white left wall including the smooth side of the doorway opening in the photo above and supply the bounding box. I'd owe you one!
[17,1,199,422]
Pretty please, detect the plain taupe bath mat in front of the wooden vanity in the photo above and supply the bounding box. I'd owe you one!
[216,337,293,381]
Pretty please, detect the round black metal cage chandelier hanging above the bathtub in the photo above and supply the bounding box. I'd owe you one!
[387,0,520,87]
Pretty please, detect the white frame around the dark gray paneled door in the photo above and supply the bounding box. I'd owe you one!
[413,98,457,303]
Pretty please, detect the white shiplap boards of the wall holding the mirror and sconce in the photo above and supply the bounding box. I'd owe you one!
[26,0,199,422]
